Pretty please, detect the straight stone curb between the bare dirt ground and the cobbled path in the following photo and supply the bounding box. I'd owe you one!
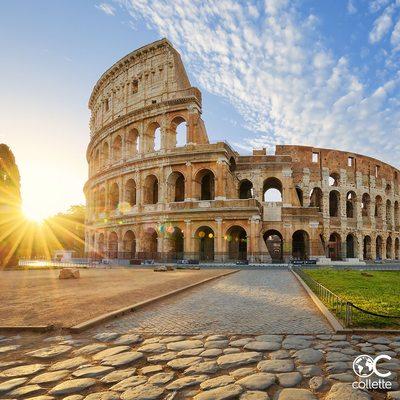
[65,269,240,333]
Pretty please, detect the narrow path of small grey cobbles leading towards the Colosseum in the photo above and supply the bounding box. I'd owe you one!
[98,269,331,335]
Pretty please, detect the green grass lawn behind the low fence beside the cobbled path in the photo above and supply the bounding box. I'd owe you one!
[305,268,400,329]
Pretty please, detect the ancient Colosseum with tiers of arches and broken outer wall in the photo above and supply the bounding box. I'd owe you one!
[84,39,400,263]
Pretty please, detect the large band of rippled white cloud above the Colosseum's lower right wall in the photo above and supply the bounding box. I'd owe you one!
[121,0,400,164]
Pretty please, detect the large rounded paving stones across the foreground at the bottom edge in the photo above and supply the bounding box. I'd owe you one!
[0,331,400,400]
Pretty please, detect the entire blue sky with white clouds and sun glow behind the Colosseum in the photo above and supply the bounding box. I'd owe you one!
[0,0,400,219]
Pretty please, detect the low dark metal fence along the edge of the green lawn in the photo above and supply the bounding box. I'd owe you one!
[292,267,400,329]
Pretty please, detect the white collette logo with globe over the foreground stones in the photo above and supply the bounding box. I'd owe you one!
[352,354,392,389]
